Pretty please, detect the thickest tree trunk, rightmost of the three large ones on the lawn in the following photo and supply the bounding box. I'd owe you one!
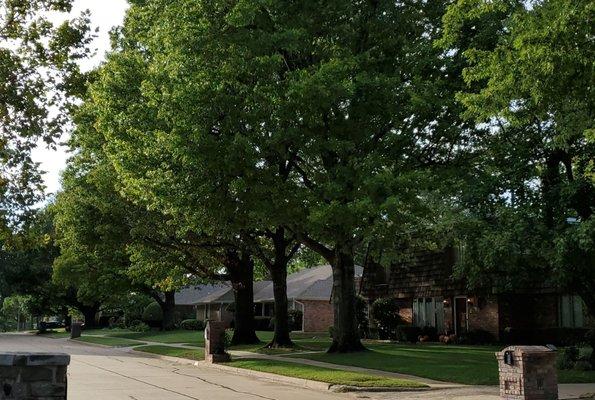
[328,247,366,353]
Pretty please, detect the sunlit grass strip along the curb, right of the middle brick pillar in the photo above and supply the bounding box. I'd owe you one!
[225,359,427,388]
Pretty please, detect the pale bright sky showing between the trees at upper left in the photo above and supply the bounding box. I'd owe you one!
[33,0,128,194]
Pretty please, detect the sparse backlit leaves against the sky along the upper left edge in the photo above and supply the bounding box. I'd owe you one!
[0,0,90,225]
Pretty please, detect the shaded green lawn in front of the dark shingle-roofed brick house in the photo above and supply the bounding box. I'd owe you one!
[289,344,595,385]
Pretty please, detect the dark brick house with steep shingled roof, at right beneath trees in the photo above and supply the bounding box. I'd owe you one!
[360,249,592,343]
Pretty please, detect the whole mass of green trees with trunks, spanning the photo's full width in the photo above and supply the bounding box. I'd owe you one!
[0,0,595,358]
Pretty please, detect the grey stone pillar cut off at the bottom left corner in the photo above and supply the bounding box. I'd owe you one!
[0,353,70,400]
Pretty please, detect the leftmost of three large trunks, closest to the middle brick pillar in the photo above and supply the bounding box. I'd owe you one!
[227,251,260,345]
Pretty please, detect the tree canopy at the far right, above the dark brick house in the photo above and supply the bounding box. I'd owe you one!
[440,0,595,313]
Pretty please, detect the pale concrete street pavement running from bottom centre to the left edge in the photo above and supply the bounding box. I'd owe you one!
[0,335,353,400]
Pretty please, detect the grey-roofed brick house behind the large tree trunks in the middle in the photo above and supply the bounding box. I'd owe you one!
[176,265,363,332]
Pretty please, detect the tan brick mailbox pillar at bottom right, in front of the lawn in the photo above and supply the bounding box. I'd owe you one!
[496,346,558,400]
